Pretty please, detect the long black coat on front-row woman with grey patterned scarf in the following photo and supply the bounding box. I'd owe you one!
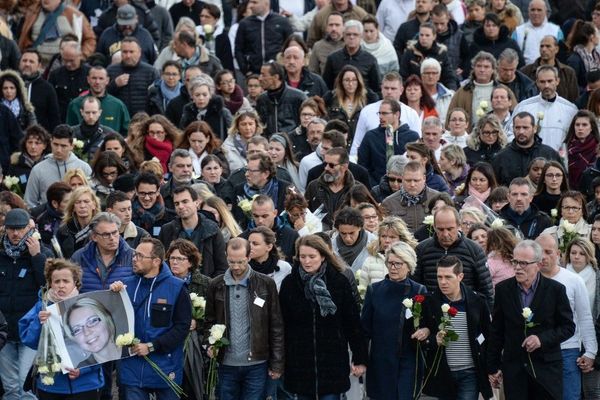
[279,265,368,398]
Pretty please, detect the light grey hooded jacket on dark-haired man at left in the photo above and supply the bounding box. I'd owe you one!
[24,152,92,207]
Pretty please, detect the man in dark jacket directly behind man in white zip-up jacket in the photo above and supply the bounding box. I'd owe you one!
[521,35,587,105]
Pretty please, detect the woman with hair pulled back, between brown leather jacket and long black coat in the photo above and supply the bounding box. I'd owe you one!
[248,226,292,291]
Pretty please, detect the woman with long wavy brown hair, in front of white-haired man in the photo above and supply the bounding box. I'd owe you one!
[323,65,377,145]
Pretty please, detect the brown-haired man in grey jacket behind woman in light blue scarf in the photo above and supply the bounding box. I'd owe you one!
[173,30,223,78]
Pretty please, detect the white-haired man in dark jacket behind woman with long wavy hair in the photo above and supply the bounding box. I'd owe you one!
[323,20,380,92]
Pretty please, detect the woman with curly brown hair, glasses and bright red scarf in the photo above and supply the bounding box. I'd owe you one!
[129,114,181,171]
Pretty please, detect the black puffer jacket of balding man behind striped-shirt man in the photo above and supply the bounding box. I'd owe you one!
[413,233,494,309]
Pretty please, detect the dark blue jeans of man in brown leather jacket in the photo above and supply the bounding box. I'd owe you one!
[219,362,267,400]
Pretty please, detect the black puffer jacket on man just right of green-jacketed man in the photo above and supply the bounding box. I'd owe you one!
[107,61,159,116]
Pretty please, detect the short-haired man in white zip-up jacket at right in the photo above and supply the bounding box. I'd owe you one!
[513,65,577,151]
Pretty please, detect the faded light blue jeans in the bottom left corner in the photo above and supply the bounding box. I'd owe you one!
[0,342,36,400]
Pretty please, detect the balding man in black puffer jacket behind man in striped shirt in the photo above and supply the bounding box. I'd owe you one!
[414,206,494,308]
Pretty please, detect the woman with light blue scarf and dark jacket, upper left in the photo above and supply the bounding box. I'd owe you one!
[147,60,183,115]
